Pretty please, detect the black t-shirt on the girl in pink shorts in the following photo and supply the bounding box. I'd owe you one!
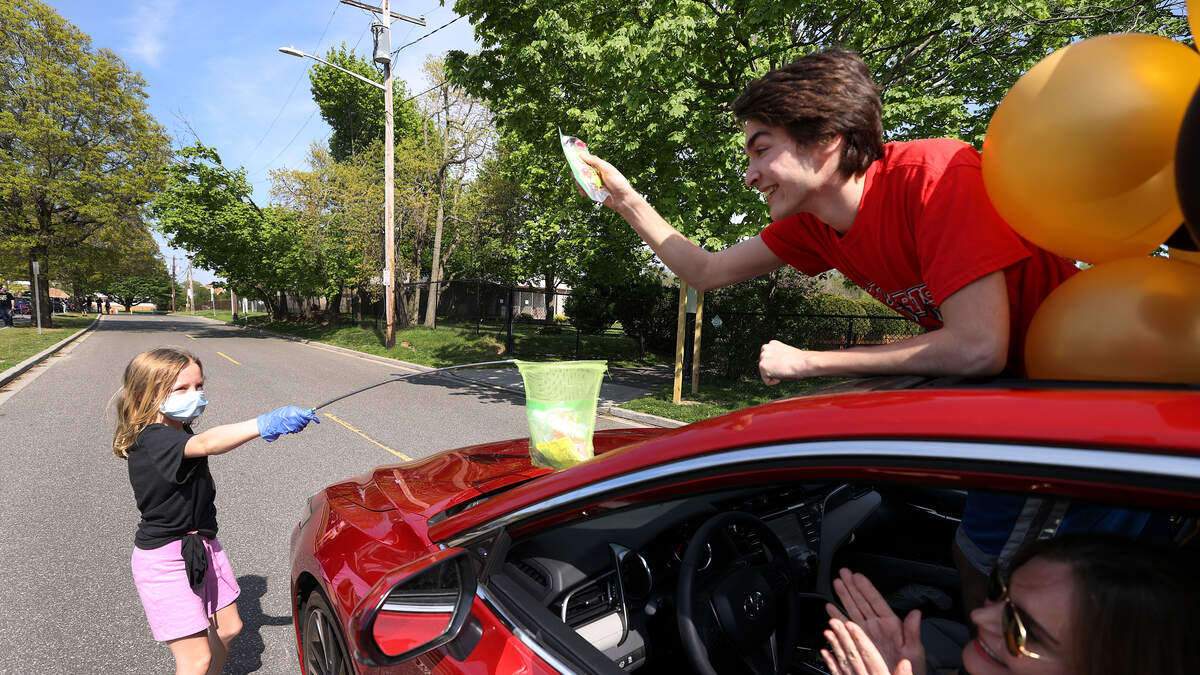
[128,424,217,549]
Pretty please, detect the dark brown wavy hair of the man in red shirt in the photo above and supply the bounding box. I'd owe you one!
[733,48,883,178]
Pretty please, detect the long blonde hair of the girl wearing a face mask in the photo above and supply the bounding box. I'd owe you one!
[113,347,204,459]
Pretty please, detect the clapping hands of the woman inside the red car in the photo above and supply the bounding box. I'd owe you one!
[826,569,925,675]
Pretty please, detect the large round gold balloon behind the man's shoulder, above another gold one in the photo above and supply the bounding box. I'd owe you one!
[983,34,1200,263]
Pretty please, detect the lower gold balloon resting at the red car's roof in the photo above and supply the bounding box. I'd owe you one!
[1025,257,1200,383]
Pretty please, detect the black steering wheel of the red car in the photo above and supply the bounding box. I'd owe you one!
[676,510,799,675]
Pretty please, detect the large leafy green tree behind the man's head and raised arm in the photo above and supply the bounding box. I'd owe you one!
[446,0,1187,254]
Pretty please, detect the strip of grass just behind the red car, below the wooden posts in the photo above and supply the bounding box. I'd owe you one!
[620,377,845,423]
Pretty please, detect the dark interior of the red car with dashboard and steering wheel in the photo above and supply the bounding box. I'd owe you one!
[472,480,1200,674]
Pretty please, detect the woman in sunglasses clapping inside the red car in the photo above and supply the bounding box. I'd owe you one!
[821,533,1200,675]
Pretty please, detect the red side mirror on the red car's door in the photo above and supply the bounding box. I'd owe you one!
[350,549,475,665]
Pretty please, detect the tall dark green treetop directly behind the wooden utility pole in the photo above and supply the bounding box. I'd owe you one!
[308,42,420,161]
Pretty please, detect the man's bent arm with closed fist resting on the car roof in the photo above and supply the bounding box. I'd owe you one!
[758,271,1009,384]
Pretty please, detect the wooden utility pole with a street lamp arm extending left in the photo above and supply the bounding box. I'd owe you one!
[280,30,396,350]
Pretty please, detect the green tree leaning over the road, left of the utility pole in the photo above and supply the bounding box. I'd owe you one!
[151,144,302,318]
